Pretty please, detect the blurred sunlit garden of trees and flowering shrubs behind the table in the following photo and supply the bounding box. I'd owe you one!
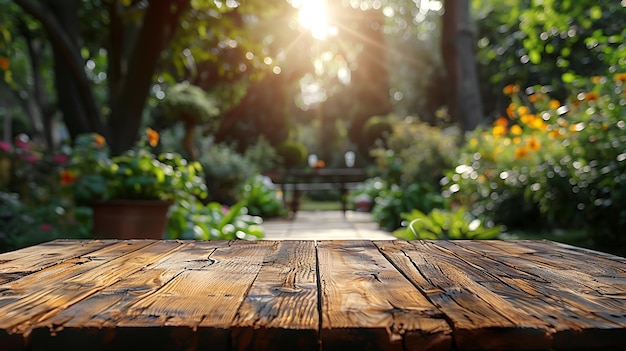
[0,0,626,255]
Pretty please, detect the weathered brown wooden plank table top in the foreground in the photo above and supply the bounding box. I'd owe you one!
[0,240,626,350]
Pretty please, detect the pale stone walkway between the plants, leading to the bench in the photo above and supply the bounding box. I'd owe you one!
[263,211,396,240]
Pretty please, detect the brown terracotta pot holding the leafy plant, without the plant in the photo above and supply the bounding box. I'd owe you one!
[92,200,172,239]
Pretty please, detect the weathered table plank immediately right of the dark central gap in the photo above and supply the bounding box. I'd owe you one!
[318,241,452,350]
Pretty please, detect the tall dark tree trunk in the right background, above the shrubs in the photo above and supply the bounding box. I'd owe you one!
[441,0,483,131]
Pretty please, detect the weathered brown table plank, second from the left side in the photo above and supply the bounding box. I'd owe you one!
[0,241,180,335]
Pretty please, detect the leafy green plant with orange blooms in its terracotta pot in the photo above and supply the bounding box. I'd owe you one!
[64,128,206,239]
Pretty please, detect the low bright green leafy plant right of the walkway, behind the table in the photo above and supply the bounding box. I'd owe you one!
[393,208,501,240]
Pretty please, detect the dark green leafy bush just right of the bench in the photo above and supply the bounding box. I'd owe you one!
[372,183,446,231]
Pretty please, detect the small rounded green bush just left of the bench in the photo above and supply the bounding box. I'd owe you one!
[242,175,287,218]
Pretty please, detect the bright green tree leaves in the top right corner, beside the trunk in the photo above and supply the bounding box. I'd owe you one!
[472,0,626,114]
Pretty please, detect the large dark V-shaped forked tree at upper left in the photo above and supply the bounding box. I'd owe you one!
[9,0,208,152]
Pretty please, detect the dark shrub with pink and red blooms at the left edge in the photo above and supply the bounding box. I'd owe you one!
[0,135,89,251]
